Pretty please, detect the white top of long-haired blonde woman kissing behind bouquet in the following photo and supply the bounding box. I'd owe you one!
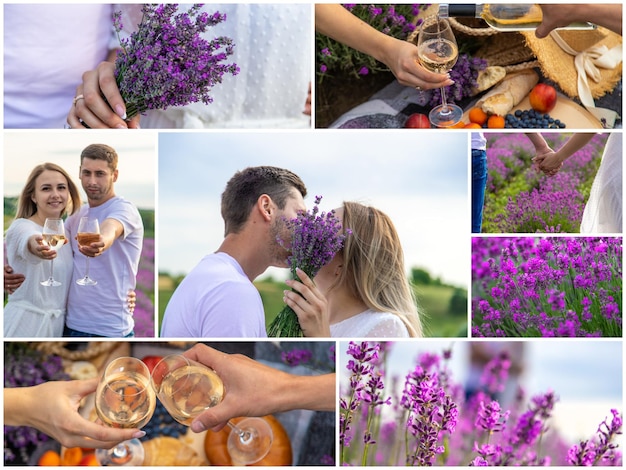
[330,310,409,338]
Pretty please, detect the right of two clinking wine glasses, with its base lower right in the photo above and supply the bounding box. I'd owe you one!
[151,354,274,465]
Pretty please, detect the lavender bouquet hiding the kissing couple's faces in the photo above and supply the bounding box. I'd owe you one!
[267,196,349,337]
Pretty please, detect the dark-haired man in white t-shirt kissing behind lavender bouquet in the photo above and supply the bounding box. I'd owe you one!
[161,166,306,338]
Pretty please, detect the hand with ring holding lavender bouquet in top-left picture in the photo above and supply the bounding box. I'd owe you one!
[67,61,139,129]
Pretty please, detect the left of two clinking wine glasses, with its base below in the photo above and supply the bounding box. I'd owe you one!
[95,356,156,466]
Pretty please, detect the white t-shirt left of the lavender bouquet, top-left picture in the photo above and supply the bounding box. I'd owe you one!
[4,3,119,129]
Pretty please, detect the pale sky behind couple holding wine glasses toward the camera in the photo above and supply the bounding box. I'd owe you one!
[3,130,157,209]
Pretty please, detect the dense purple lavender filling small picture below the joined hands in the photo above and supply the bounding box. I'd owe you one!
[471,237,622,337]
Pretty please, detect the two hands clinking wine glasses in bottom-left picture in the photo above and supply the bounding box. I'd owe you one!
[4,343,336,465]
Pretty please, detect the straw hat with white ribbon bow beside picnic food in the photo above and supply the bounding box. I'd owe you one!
[521,27,622,99]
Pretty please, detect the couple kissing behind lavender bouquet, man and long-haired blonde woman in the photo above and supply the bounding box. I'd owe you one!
[161,166,422,338]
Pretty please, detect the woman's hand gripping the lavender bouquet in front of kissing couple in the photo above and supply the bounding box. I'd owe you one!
[283,268,330,338]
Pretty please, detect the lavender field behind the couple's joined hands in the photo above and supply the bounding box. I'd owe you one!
[483,133,608,233]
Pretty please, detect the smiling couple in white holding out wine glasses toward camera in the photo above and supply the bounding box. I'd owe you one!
[4,144,143,337]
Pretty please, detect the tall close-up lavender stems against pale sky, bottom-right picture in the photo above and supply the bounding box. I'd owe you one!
[339,342,623,466]
